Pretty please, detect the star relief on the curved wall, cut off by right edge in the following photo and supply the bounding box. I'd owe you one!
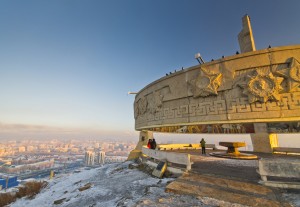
[275,58,300,92]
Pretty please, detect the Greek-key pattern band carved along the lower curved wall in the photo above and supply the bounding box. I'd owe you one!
[137,92,300,123]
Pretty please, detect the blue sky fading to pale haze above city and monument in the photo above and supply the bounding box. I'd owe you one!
[0,0,300,138]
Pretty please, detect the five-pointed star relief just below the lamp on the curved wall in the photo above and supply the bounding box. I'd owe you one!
[189,68,222,98]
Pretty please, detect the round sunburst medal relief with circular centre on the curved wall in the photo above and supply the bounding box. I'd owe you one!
[239,69,283,103]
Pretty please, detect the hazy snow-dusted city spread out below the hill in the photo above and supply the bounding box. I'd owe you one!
[0,139,135,179]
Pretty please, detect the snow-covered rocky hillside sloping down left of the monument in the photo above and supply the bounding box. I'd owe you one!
[11,162,210,207]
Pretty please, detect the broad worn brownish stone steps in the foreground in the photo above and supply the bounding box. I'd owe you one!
[166,173,290,207]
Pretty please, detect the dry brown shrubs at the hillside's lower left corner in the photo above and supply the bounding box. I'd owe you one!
[0,181,48,207]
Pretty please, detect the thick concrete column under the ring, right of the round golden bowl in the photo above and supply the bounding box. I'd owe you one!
[251,123,278,153]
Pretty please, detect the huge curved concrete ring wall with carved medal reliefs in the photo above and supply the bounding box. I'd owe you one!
[134,45,300,133]
